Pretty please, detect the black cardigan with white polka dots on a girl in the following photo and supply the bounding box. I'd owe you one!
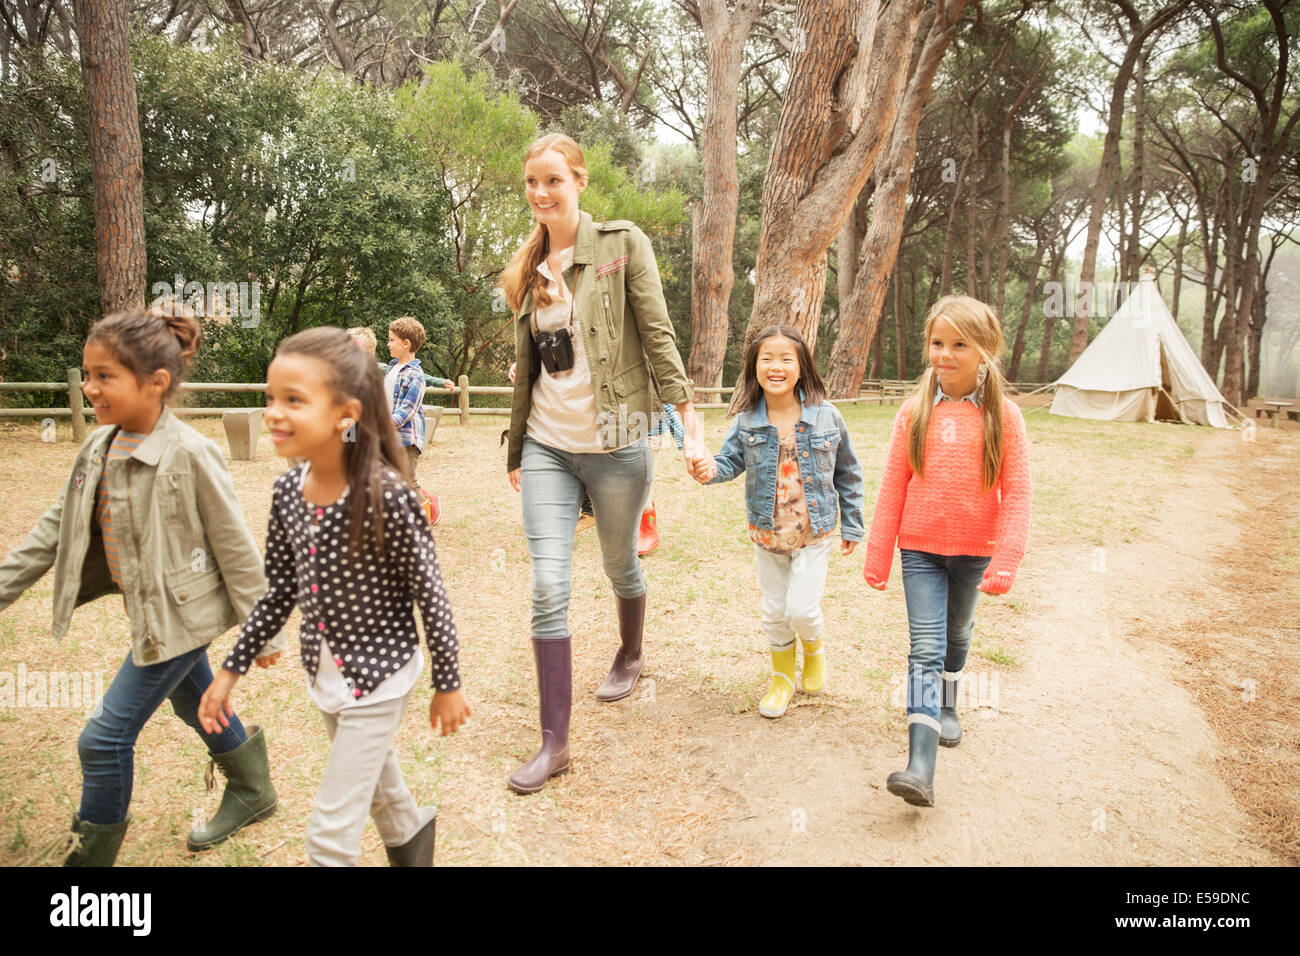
[222,466,460,697]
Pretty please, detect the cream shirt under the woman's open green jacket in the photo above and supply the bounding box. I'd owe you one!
[525,246,610,454]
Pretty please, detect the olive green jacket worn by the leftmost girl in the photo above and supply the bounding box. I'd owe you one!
[0,407,285,666]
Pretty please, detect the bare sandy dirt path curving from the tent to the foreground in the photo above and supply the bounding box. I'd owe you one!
[681,436,1300,865]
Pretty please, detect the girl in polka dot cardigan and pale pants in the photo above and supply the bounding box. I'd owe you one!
[199,328,469,866]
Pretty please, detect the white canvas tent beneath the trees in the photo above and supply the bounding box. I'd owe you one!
[1052,274,1229,428]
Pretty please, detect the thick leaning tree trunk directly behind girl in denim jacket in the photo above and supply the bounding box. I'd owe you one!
[745,0,924,349]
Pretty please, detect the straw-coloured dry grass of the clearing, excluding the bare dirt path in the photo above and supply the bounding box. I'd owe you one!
[0,407,1294,866]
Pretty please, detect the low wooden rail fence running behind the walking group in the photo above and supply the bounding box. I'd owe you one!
[0,368,1043,444]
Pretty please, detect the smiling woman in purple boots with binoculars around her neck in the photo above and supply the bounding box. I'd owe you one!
[501,133,712,793]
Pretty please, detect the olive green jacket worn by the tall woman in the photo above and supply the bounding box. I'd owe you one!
[506,212,694,471]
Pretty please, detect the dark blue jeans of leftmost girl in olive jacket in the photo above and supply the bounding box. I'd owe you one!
[77,646,248,826]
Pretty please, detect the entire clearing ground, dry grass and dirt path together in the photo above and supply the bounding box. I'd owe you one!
[0,407,1300,865]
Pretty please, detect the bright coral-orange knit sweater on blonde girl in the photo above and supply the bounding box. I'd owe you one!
[862,398,1031,591]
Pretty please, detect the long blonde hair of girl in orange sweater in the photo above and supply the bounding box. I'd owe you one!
[907,295,1006,492]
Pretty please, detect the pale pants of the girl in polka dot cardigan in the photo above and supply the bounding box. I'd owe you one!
[307,693,421,866]
